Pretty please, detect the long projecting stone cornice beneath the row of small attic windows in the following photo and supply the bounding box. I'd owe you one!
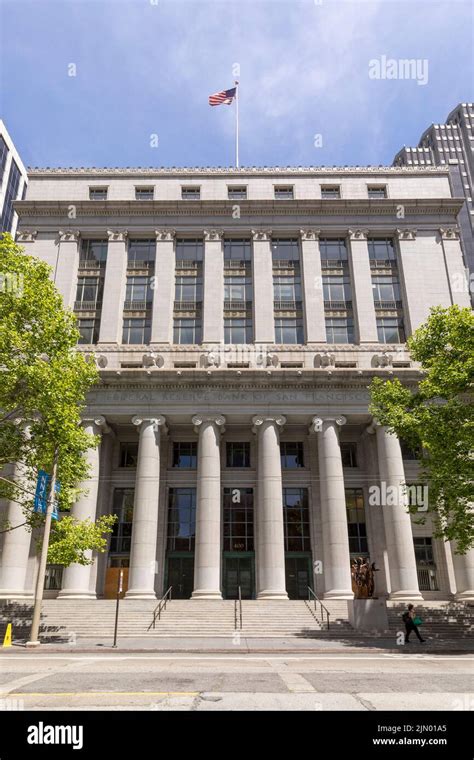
[14,198,464,218]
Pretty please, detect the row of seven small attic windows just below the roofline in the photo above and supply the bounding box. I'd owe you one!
[89,185,387,201]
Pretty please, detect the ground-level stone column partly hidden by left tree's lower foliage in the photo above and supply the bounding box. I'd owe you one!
[58,415,107,599]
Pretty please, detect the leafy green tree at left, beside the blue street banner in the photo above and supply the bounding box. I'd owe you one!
[0,234,115,565]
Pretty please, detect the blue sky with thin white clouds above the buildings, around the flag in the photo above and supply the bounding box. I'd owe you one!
[0,0,474,166]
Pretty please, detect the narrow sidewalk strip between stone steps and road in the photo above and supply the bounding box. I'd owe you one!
[1,636,474,656]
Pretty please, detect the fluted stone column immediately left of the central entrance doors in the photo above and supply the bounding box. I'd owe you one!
[192,414,225,599]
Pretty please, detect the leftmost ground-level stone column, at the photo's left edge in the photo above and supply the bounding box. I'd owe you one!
[0,448,35,599]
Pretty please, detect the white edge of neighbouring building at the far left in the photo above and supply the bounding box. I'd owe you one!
[0,119,28,236]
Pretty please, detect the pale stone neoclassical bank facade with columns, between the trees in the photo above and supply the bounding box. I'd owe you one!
[0,167,474,600]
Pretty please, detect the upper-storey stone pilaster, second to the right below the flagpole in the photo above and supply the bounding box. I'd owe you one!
[300,230,326,343]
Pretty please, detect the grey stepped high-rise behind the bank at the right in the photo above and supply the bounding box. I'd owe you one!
[393,103,474,275]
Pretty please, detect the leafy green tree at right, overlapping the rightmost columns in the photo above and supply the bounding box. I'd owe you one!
[370,306,474,554]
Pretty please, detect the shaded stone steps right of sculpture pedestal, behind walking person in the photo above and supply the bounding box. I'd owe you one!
[387,601,474,641]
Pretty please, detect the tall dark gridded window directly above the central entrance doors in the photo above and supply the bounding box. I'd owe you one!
[222,487,254,552]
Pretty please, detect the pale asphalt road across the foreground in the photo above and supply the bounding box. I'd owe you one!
[0,650,474,711]
